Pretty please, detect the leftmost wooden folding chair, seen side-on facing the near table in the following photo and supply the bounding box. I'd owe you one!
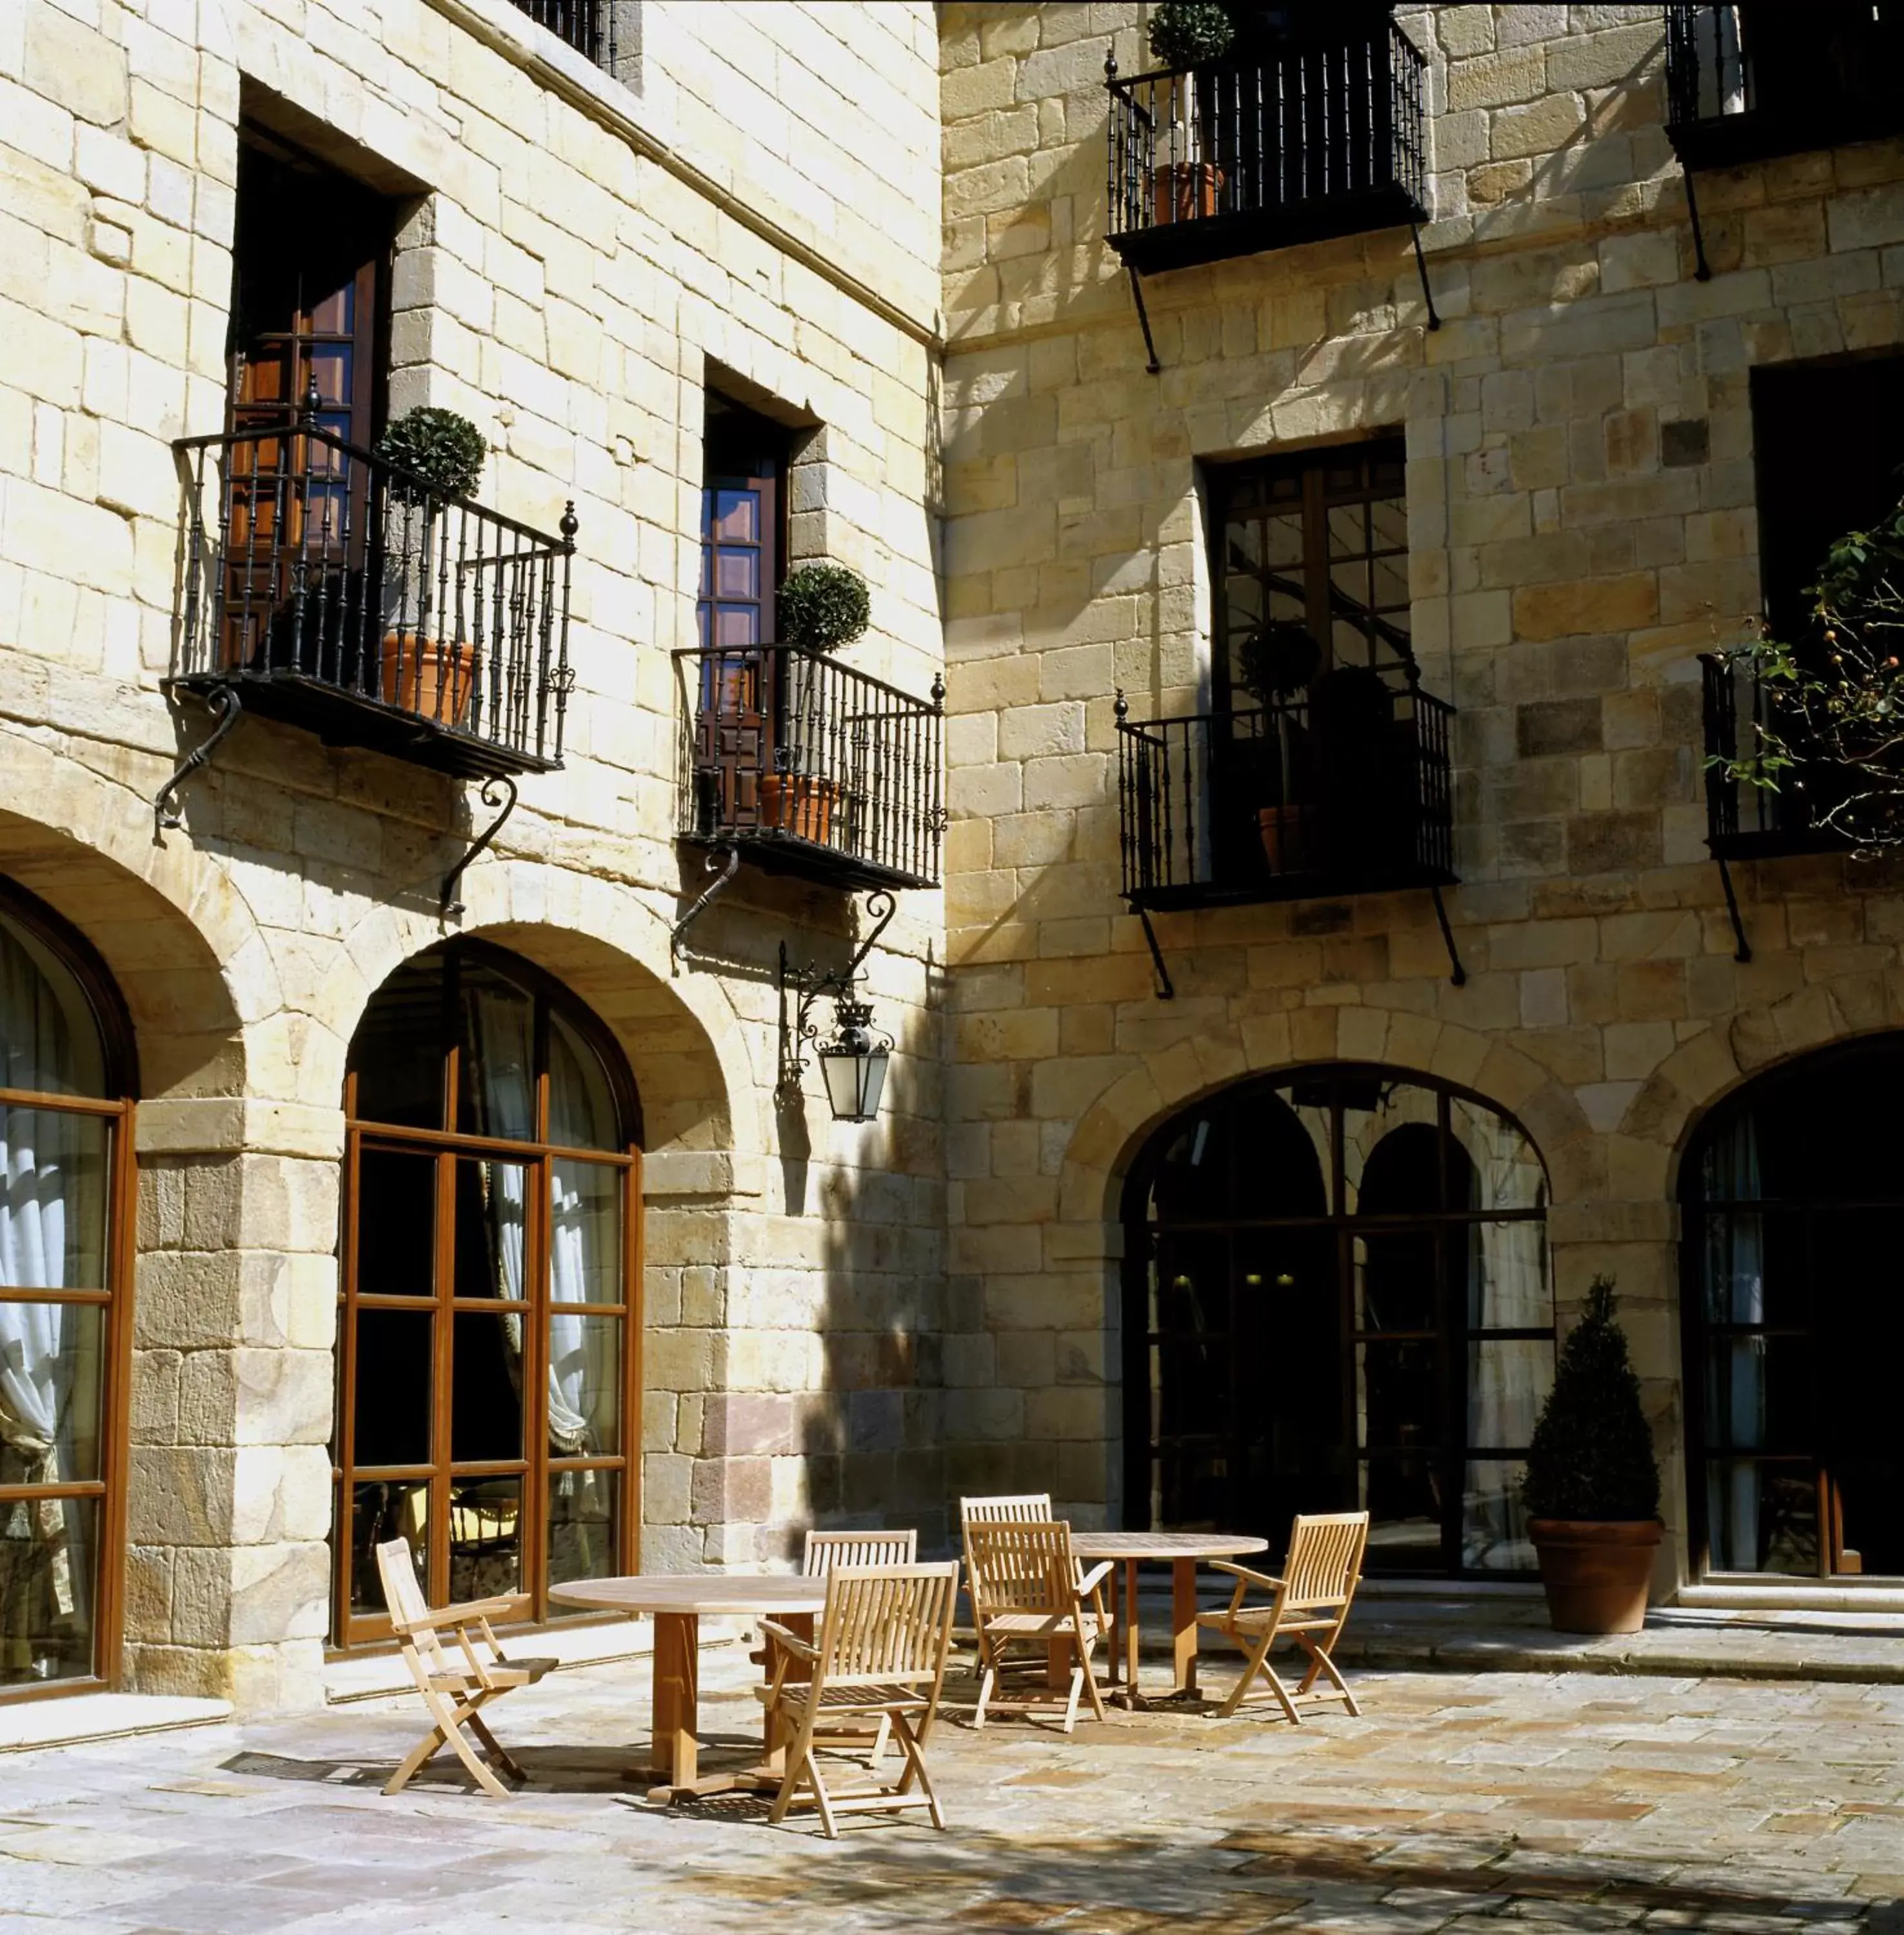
[377,1538,557,1800]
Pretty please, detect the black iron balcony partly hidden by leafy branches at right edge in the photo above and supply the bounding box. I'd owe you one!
[1699,652,1852,859]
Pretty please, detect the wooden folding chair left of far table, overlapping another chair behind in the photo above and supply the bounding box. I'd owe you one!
[966,1519,1113,1734]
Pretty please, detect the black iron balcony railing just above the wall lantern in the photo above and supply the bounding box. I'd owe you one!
[675,644,944,888]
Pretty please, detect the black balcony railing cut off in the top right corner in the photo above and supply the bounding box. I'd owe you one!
[1666,0,1904,168]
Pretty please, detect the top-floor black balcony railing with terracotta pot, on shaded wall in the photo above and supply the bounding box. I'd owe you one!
[1107,21,1428,271]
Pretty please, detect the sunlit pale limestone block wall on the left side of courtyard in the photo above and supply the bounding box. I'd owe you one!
[0,0,942,1705]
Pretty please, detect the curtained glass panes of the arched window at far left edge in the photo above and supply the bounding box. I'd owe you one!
[0,925,99,1674]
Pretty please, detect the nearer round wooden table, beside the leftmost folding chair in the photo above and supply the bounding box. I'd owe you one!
[550,1573,826,1800]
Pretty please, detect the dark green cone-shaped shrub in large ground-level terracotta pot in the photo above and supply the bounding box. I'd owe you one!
[1521,1277,1660,1519]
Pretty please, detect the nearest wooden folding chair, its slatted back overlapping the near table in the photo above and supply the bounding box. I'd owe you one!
[764,1560,958,1840]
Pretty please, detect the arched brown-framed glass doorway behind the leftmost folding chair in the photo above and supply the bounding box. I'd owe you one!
[333,940,640,1645]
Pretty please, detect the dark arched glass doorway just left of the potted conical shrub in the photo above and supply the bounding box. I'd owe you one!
[1124,1066,1554,1573]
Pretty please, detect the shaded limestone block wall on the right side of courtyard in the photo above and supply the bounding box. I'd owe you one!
[942,6,1904,1585]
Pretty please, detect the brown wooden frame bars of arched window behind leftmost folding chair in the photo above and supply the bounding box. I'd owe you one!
[331,940,644,1651]
